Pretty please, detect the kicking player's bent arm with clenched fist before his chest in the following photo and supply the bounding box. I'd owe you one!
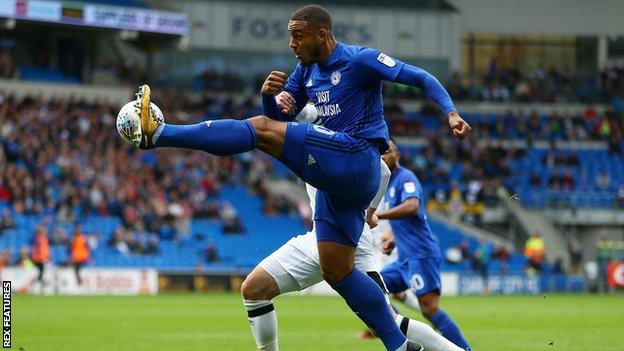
[261,66,308,121]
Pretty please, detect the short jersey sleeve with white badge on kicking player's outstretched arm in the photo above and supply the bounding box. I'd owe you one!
[355,48,404,81]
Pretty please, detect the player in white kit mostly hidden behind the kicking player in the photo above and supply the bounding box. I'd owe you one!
[241,105,461,351]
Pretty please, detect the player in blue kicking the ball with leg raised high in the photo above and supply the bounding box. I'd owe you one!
[119,6,470,351]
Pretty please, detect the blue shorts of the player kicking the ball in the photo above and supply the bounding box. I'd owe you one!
[280,122,381,247]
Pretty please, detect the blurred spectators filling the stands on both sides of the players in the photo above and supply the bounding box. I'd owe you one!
[0,84,624,269]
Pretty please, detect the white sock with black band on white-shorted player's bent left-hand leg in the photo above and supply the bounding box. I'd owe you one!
[244,300,278,351]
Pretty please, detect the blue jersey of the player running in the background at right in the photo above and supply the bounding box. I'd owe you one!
[385,167,441,260]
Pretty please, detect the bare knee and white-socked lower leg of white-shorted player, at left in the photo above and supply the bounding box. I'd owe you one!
[241,267,280,351]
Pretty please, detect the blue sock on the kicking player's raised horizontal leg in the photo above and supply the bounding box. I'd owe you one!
[153,119,257,156]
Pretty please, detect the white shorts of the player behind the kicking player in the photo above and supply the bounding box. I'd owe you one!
[258,225,379,294]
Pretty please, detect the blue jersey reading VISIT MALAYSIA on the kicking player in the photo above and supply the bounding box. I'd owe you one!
[284,43,404,151]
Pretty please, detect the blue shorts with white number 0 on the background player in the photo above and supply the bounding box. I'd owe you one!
[381,258,442,296]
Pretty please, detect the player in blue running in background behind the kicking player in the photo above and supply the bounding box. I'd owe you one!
[377,140,470,350]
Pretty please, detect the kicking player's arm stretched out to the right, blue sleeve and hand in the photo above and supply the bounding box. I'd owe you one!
[356,48,471,139]
